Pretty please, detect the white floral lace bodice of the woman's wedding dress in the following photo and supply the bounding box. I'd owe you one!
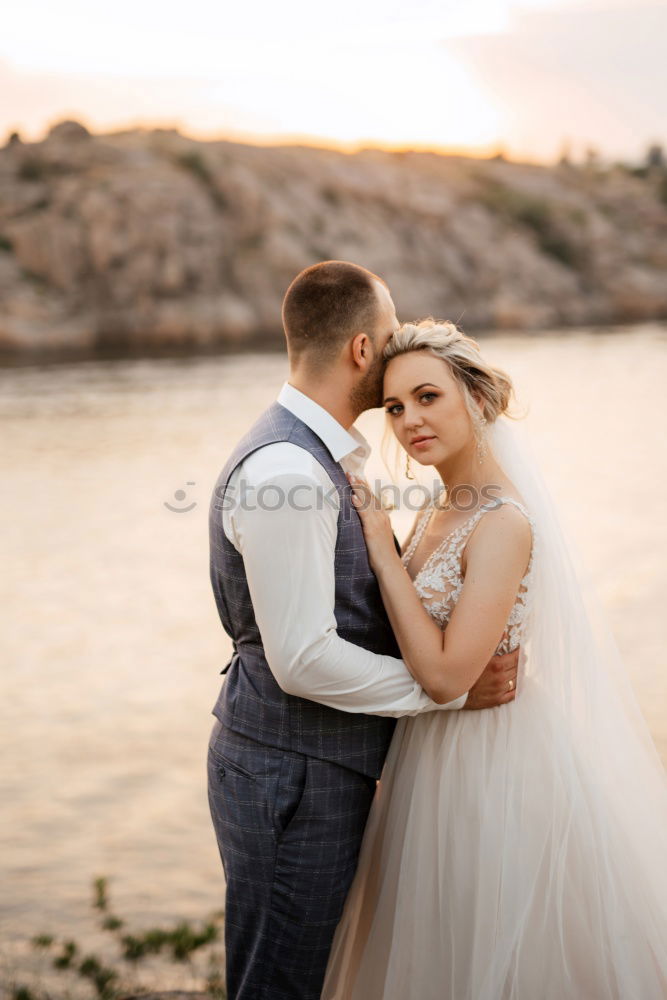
[401,497,535,653]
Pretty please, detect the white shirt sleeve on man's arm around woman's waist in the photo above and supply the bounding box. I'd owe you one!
[228,460,467,716]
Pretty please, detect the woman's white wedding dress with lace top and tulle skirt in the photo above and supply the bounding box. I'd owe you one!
[322,482,667,1000]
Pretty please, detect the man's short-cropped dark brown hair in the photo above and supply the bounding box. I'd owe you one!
[283,260,386,369]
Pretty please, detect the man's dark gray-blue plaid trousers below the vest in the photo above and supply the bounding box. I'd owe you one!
[208,722,375,1000]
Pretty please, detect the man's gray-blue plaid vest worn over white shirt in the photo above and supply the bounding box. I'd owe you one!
[209,403,400,778]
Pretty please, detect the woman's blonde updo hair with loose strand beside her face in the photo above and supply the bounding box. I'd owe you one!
[382,316,514,476]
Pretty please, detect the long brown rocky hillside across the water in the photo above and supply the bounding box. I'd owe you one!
[0,121,667,352]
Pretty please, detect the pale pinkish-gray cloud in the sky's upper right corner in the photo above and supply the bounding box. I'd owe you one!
[443,0,667,158]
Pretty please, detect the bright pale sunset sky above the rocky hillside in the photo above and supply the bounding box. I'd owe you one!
[0,0,667,161]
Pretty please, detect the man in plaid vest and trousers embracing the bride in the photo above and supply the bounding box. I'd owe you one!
[208,261,518,1000]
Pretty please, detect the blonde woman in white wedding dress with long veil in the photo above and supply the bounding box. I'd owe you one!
[322,320,667,1000]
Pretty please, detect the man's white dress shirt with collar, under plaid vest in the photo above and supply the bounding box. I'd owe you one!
[222,382,468,716]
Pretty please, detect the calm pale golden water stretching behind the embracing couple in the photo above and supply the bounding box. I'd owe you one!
[0,325,667,968]
